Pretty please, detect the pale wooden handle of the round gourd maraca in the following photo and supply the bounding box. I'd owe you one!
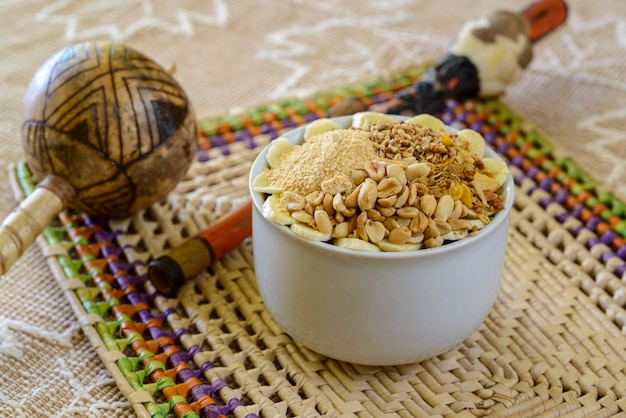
[0,175,74,274]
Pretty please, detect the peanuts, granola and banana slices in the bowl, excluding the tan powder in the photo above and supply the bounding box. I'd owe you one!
[255,114,508,251]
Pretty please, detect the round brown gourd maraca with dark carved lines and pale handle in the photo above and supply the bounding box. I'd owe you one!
[0,42,196,274]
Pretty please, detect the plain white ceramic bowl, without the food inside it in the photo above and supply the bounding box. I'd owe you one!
[250,116,514,365]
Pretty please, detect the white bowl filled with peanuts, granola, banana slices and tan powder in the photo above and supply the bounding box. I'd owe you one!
[249,112,514,365]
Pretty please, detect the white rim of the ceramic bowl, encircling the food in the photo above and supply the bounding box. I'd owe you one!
[248,114,515,260]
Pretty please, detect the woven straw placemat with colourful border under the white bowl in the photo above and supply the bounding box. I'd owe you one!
[10,69,626,418]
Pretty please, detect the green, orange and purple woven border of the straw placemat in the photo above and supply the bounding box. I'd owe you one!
[17,69,626,418]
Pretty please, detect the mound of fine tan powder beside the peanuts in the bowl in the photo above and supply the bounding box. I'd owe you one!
[266,129,376,196]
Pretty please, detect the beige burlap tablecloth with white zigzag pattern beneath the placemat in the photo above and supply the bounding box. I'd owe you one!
[0,0,626,417]
